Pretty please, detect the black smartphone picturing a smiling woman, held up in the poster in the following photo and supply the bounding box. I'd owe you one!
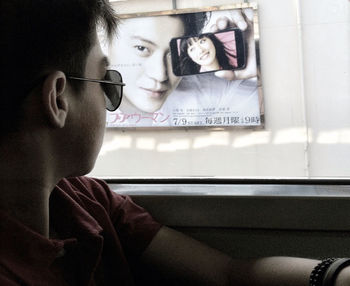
[170,28,246,76]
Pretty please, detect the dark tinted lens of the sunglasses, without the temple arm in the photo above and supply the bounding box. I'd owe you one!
[102,70,123,111]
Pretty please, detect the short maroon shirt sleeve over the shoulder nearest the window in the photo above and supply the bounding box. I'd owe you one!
[68,177,162,258]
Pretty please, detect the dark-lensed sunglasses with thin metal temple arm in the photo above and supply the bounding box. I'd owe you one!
[67,70,125,111]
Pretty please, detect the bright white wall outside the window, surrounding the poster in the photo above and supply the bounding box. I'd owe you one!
[91,0,350,177]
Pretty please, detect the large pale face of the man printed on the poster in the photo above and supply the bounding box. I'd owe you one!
[110,16,184,112]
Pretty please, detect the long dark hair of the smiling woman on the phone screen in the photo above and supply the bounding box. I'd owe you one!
[179,33,236,75]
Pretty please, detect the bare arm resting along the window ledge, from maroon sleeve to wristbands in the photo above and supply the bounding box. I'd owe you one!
[142,227,350,286]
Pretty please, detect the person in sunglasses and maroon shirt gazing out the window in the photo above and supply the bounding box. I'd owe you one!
[0,0,349,286]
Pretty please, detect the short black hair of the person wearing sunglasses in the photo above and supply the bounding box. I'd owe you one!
[0,0,117,134]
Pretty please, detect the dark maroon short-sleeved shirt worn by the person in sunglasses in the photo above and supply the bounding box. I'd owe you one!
[0,177,161,286]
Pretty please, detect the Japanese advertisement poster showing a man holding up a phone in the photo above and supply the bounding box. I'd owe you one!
[107,4,263,128]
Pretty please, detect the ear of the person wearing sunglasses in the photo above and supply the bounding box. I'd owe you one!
[42,71,68,128]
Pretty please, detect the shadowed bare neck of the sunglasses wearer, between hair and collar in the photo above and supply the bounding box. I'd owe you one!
[0,134,57,237]
